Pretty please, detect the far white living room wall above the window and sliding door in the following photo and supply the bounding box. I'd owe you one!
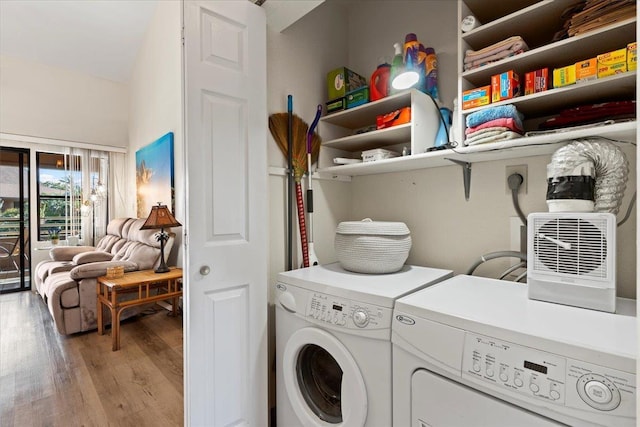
[0,56,129,147]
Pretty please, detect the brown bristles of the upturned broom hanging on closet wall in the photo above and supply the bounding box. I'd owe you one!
[269,113,322,180]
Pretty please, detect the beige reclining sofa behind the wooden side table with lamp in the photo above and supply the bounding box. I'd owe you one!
[34,218,175,335]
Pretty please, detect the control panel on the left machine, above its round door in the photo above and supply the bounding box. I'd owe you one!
[305,292,391,329]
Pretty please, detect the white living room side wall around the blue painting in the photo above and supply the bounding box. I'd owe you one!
[126,1,185,265]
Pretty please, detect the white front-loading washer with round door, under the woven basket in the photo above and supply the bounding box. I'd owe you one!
[275,263,452,427]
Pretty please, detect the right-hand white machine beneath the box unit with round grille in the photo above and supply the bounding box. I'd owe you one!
[392,275,637,427]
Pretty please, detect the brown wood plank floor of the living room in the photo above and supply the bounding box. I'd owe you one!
[0,291,183,427]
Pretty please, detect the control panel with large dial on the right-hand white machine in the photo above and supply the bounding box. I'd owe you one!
[462,332,636,416]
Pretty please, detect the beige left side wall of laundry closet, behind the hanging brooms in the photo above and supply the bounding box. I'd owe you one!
[267,3,350,290]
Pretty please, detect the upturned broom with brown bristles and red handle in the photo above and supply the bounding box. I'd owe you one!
[269,109,321,267]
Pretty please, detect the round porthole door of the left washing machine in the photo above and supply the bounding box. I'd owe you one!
[282,327,367,427]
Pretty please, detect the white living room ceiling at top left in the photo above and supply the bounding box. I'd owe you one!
[0,0,158,83]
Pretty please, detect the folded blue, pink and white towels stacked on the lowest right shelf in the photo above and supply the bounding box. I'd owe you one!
[464,104,524,145]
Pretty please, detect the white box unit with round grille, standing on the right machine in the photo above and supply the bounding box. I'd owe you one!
[527,212,616,313]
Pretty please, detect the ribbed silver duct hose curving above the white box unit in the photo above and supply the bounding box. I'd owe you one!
[547,137,629,215]
